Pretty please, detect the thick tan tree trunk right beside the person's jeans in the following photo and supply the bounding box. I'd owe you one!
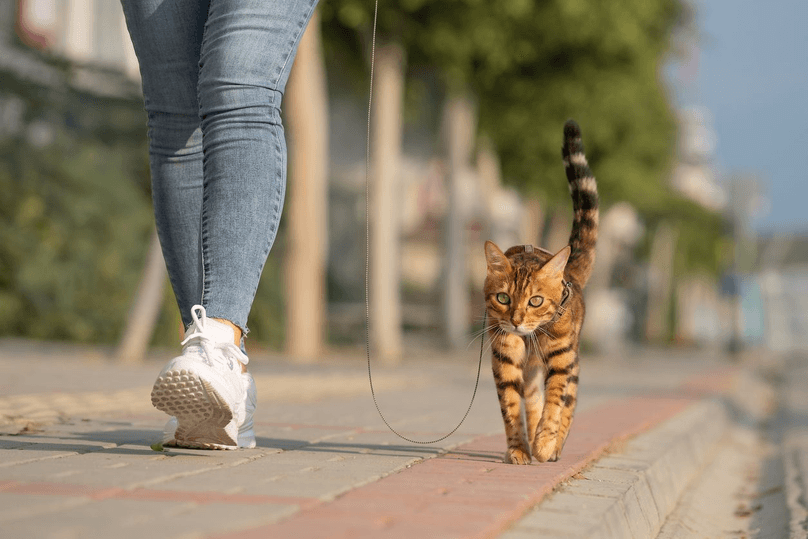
[284,11,328,361]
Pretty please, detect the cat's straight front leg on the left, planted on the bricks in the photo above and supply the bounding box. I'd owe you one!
[491,333,530,464]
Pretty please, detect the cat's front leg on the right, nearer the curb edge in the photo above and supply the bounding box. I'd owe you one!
[533,341,578,462]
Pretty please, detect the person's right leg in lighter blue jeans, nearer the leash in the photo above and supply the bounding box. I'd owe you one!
[199,0,316,338]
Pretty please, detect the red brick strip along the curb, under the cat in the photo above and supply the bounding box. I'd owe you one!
[218,369,735,539]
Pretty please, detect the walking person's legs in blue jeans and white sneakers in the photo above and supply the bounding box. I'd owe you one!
[124,0,316,449]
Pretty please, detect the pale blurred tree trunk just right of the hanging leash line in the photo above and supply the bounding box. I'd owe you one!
[368,43,405,362]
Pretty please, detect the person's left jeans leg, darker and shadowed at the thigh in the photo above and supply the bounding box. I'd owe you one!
[122,0,208,327]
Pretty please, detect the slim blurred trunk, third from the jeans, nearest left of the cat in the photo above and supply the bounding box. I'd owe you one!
[443,97,476,350]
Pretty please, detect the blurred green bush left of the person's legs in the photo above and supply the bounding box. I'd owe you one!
[0,136,151,342]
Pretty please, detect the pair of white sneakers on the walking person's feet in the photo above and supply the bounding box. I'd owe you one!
[151,305,255,449]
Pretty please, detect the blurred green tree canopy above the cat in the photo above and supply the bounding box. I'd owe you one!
[322,0,722,272]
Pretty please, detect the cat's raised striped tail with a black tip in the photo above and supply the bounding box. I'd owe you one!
[561,120,598,287]
